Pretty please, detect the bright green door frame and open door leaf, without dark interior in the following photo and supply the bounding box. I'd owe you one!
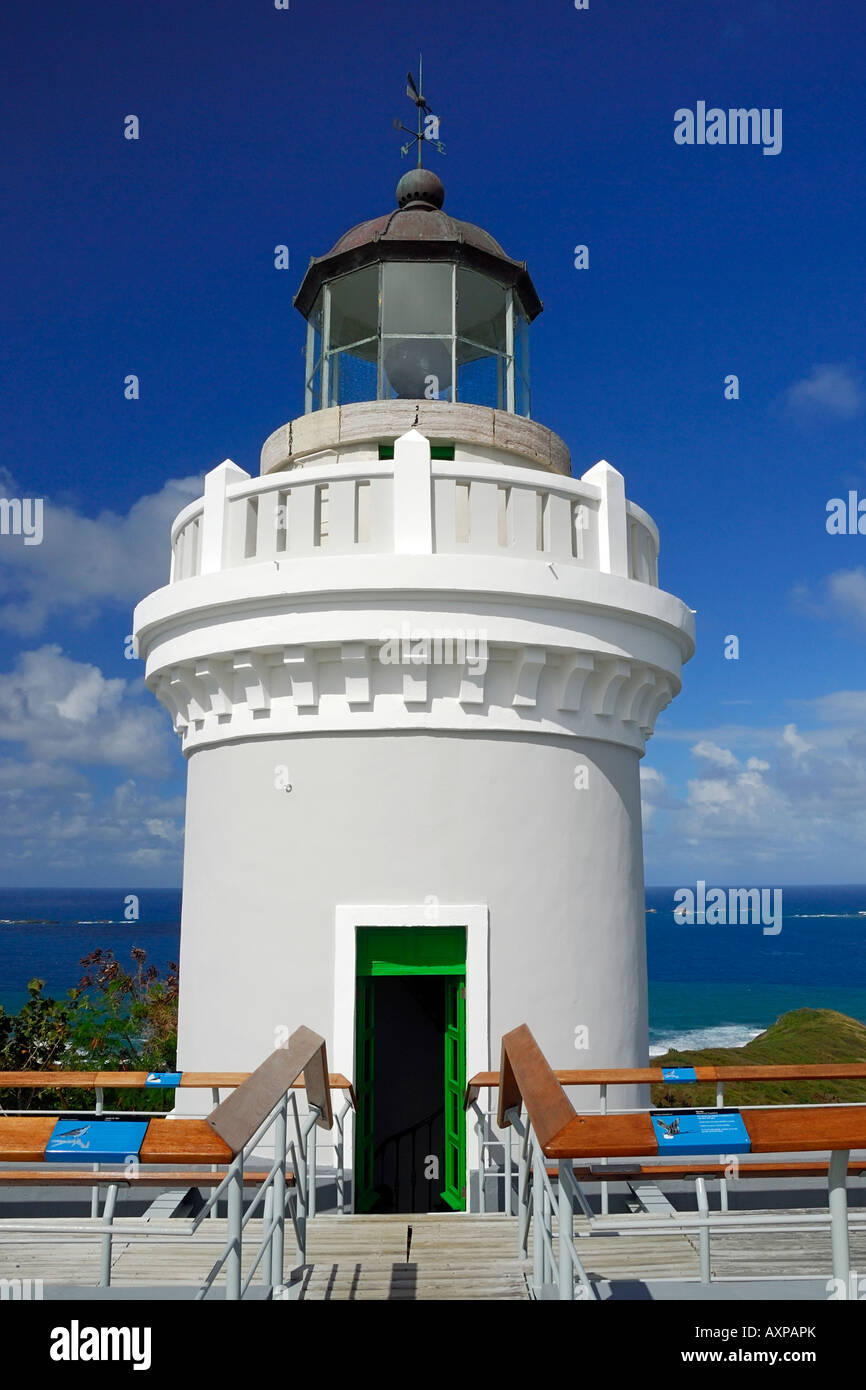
[354,926,466,1212]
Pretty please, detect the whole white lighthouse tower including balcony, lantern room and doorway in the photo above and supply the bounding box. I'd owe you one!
[135,157,694,1209]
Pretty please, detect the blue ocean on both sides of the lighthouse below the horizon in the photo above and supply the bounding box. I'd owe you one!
[0,884,866,1055]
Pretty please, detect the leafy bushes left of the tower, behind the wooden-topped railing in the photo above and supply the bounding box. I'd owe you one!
[0,947,178,1111]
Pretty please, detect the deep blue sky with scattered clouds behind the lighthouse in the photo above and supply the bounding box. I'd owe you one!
[0,0,866,887]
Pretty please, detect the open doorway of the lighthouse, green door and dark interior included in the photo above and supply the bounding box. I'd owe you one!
[354,927,466,1212]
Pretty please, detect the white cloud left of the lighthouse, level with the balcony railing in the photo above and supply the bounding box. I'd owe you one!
[0,474,202,635]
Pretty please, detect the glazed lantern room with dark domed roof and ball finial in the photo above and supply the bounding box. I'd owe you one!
[295,168,542,416]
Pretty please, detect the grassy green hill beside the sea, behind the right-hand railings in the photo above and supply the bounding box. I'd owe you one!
[652,1009,866,1106]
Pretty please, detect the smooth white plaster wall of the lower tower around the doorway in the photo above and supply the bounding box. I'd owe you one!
[179,731,646,1084]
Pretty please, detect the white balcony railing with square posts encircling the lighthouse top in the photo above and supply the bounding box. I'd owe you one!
[171,432,659,587]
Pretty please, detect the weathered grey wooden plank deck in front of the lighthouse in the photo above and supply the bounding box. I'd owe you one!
[0,1215,866,1302]
